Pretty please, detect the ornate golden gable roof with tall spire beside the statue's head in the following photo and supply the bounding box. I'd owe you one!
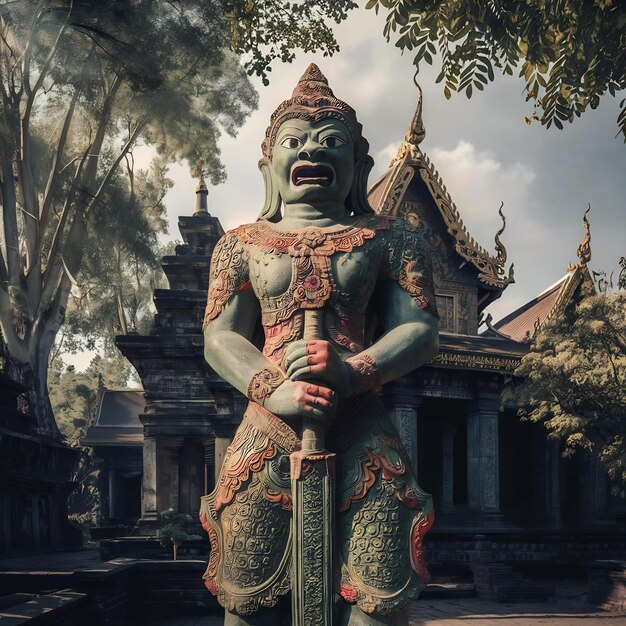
[368,83,514,291]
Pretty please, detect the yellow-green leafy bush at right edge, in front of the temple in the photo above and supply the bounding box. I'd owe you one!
[515,292,626,494]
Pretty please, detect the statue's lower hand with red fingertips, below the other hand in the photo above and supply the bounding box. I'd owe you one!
[263,378,336,423]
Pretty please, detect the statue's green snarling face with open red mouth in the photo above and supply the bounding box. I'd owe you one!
[271,118,354,205]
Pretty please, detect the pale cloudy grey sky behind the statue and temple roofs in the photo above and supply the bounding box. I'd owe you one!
[155,8,626,321]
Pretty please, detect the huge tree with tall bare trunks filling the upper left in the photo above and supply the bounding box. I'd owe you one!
[0,0,353,436]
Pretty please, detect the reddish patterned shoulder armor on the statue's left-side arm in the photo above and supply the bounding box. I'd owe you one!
[203,226,250,328]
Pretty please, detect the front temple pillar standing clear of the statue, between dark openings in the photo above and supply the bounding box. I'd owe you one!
[467,395,500,513]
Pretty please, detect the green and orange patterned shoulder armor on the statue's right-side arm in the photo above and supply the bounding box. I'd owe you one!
[378,218,439,318]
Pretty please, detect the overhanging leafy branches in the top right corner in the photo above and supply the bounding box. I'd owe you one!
[366,0,626,141]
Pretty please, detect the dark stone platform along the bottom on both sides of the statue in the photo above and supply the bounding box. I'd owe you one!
[0,550,626,626]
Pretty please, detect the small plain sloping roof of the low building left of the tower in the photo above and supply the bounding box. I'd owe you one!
[82,389,146,446]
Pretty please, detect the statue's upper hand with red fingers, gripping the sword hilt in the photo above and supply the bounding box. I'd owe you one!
[285,339,350,397]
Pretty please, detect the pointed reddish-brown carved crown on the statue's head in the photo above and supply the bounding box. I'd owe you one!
[261,63,369,161]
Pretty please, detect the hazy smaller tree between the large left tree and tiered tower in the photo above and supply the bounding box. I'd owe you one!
[58,159,175,355]
